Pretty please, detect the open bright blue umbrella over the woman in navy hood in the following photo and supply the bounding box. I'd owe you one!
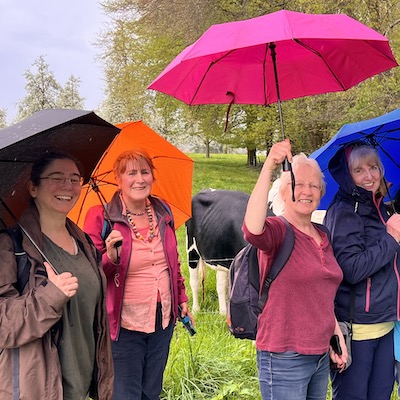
[310,108,400,210]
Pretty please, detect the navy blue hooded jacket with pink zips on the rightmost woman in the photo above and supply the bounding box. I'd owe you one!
[324,145,400,324]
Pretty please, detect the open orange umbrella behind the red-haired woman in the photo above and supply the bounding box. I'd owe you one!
[68,121,194,228]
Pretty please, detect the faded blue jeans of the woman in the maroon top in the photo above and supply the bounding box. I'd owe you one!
[257,350,329,400]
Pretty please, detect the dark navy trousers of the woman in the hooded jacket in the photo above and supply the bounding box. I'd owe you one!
[331,331,394,400]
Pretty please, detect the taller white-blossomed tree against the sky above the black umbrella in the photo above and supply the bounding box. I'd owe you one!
[17,55,61,121]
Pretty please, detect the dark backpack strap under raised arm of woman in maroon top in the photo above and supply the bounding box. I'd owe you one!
[258,216,294,312]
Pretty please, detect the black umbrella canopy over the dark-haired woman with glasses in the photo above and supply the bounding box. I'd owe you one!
[0,109,120,224]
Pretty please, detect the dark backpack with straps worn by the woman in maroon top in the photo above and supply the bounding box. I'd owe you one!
[227,217,329,340]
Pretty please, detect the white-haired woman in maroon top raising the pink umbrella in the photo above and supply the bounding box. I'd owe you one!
[243,140,347,400]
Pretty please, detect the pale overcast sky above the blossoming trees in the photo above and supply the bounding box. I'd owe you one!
[0,0,107,124]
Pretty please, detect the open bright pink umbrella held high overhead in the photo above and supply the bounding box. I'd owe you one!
[148,10,398,137]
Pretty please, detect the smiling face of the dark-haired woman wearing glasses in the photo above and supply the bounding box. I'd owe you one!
[29,159,82,216]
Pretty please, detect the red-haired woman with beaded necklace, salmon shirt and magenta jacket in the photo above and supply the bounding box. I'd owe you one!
[84,150,192,400]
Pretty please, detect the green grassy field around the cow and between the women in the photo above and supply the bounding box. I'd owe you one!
[161,154,398,400]
